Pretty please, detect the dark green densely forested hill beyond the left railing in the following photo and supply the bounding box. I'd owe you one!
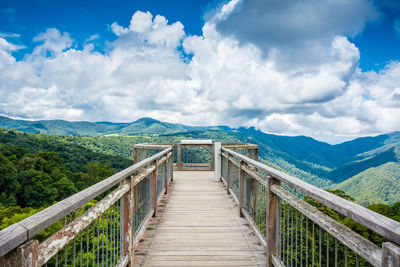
[0,129,132,208]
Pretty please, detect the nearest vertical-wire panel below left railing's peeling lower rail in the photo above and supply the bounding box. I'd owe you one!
[44,200,123,266]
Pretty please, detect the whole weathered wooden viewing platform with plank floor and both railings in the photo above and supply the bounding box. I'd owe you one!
[0,140,400,267]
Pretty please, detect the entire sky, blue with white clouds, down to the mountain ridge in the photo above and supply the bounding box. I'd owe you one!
[0,0,400,142]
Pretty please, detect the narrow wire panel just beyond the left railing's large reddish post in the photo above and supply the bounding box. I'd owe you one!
[133,174,152,236]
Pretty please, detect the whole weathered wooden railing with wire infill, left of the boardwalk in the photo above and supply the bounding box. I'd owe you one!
[0,146,173,266]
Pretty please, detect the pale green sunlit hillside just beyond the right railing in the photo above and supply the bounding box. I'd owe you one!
[332,162,400,206]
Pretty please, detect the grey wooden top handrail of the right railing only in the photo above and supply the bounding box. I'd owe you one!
[221,147,400,244]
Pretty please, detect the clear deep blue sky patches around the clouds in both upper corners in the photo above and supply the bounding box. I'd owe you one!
[0,0,400,71]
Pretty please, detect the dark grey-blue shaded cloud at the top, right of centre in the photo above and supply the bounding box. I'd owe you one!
[217,0,377,68]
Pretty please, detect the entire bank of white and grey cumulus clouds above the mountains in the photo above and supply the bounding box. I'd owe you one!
[0,0,400,144]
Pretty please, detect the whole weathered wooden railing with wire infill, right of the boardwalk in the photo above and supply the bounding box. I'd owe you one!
[216,146,400,266]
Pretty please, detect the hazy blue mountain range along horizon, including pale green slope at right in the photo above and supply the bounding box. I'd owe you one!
[0,117,400,205]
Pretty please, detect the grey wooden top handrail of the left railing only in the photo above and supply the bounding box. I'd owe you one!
[0,146,172,257]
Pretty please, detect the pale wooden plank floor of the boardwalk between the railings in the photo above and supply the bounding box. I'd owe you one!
[135,171,265,266]
